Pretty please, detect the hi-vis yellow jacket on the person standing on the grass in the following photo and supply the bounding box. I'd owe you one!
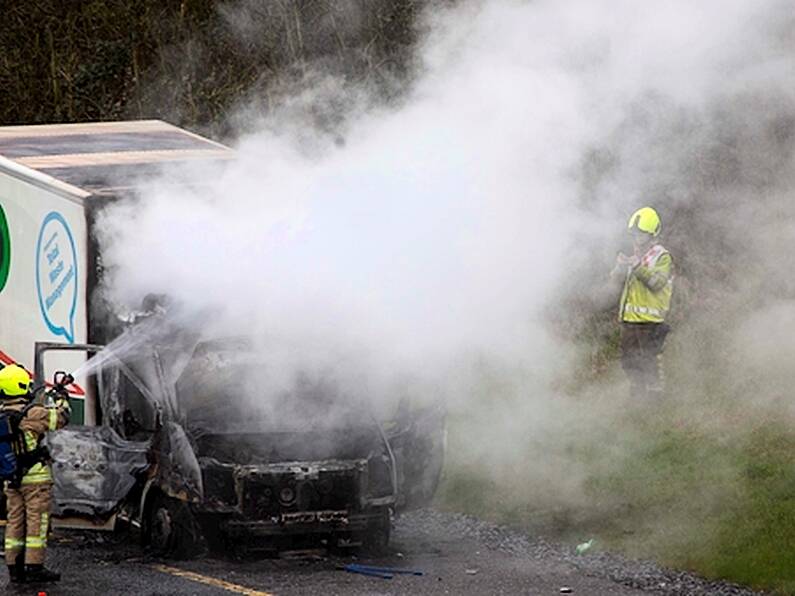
[618,244,673,323]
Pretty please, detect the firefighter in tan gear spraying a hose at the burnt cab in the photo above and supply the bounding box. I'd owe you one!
[0,364,70,583]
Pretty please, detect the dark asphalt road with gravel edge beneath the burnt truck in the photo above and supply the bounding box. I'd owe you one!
[0,511,753,596]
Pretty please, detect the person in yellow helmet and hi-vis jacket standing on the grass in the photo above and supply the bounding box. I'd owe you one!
[614,207,673,399]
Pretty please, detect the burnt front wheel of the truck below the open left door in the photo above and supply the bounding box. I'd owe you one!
[144,495,204,559]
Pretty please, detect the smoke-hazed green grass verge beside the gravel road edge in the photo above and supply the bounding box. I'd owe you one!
[439,394,795,594]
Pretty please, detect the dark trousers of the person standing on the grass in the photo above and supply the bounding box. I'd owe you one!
[621,323,671,398]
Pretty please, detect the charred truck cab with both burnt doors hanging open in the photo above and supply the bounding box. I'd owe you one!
[37,324,444,557]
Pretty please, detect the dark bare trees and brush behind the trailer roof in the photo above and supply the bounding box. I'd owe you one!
[0,0,422,134]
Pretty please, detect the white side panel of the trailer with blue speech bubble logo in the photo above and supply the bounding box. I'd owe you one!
[0,157,87,420]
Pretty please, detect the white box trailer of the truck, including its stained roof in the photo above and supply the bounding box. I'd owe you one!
[0,120,234,425]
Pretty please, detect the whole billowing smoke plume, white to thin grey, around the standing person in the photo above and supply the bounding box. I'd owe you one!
[101,0,795,540]
